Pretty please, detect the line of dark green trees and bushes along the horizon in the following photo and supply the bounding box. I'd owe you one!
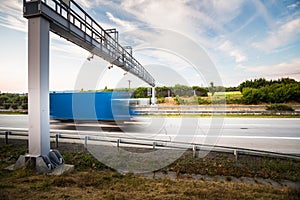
[0,78,300,110]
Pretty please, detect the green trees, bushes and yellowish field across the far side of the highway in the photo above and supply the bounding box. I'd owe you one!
[0,78,300,114]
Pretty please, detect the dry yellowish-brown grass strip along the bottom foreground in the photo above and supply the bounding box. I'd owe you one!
[0,171,297,199]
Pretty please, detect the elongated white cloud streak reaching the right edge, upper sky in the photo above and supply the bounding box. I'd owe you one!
[253,18,300,52]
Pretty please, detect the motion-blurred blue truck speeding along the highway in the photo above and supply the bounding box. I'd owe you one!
[50,92,134,121]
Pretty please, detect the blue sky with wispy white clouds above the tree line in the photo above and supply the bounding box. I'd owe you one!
[0,0,300,93]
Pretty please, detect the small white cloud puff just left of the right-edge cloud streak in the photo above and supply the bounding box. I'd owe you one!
[218,40,247,63]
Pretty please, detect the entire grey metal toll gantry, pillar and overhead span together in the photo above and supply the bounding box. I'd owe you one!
[23,0,155,170]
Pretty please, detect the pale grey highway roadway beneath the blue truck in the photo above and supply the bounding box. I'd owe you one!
[0,115,300,154]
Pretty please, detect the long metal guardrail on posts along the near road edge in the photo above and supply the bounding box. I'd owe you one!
[0,127,300,160]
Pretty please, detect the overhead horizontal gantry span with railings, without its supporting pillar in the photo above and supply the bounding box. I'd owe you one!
[23,0,155,86]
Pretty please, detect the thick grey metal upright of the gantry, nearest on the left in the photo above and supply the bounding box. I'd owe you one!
[28,17,50,156]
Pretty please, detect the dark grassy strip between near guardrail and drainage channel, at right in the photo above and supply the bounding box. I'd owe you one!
[163,151,300,181]
